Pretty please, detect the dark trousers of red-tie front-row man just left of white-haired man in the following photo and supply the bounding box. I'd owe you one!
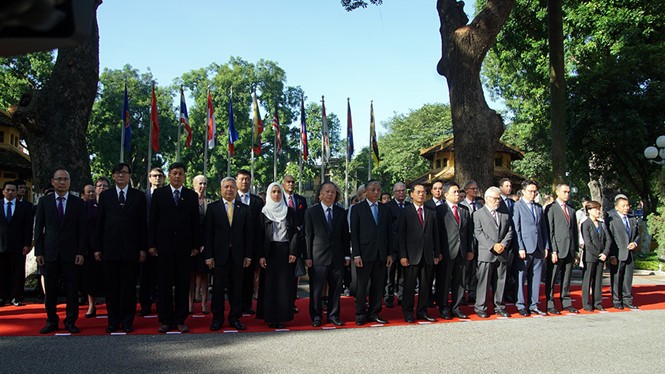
[436,253,466,312]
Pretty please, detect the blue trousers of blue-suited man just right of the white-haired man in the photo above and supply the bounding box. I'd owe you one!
[514,250,543,310]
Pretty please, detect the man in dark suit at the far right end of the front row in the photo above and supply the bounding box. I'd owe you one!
[605,196,639,309]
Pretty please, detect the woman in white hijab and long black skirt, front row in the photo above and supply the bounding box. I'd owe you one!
[256,182,298,329]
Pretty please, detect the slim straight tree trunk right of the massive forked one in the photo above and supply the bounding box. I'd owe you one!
[547,0,566,185]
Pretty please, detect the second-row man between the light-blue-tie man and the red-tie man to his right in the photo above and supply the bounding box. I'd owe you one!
[384,182,411,308]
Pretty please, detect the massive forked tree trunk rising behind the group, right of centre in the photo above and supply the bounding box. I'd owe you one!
[436,0,515,189]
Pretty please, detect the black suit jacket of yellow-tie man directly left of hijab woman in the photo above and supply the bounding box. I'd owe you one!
[203,199,256,267]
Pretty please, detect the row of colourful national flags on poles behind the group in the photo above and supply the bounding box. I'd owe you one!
[120,82,380,196]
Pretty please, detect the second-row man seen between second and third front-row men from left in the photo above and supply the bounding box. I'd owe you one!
[138,167,165,317]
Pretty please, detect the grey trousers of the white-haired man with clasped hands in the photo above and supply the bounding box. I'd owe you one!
[474,261,508,312]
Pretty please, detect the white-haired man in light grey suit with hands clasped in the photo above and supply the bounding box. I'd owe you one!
[472,187,513,318]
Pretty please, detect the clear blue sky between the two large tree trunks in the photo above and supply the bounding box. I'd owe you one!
[98,0,473,149]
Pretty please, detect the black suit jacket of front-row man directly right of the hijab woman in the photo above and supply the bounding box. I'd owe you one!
[305,203,351,267]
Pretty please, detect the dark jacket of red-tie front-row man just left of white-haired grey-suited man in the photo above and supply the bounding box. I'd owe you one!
[436,202,473,261]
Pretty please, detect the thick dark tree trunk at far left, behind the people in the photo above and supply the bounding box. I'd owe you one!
[12,0,99,191]
